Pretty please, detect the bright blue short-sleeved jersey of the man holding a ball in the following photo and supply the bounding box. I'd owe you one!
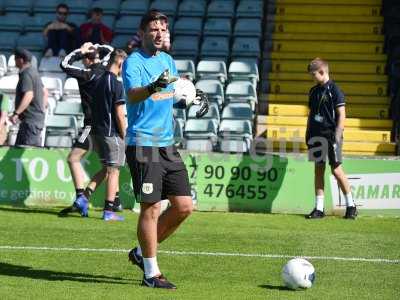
[122,51,178,147]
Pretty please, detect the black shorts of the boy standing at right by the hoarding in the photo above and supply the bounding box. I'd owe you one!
[307,139,343,167]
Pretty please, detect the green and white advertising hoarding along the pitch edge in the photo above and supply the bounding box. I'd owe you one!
[0,147,400,216]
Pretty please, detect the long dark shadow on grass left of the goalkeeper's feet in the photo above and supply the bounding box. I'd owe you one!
[0,262,139,284]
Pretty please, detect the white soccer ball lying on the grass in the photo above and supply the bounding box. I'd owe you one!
[282,258,315,290]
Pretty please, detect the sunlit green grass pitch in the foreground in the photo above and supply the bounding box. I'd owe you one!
[0,206,400,299]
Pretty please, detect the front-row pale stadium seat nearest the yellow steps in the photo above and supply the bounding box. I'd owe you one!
[218,120,253,153]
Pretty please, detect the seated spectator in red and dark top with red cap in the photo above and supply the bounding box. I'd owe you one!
[80,7,113,44]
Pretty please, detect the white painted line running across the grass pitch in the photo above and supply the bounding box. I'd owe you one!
[0,245,400,264]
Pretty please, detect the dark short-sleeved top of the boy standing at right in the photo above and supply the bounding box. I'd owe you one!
[308,80,345,138]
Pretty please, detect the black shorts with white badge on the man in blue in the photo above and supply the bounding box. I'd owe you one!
[126,146,191,203]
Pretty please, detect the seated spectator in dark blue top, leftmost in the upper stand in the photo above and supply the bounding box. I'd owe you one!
[43,3,77,57]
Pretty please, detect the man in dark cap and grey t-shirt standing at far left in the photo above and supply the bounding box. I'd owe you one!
[10,47,48,147]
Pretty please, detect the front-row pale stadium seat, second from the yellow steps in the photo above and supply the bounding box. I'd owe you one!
[184,119,218,151]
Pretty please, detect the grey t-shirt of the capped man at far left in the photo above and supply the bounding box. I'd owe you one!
[15,66,45,128]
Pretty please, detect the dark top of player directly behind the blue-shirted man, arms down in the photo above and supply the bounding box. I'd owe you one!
[91,71,125,136]
